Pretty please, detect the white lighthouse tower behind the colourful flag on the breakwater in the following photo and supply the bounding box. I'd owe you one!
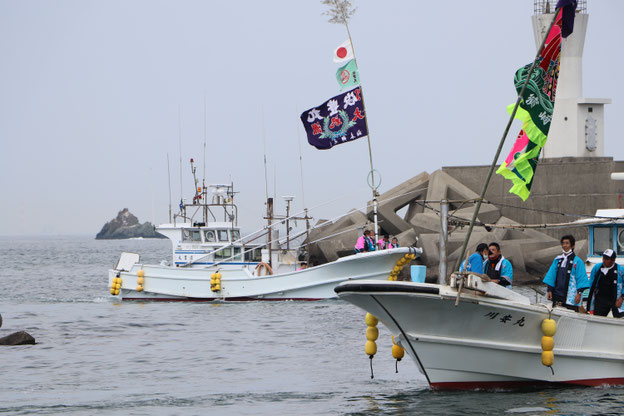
[533,0,611,158]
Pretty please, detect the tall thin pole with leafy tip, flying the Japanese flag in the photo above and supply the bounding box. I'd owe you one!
[321,0,381,239]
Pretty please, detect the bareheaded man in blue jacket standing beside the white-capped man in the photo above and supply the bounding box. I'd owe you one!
[543,235,590,311]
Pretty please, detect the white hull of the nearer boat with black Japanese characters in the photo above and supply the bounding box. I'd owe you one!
[336,282,624,389]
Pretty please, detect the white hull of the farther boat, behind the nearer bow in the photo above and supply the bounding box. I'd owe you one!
[108,248,418,301]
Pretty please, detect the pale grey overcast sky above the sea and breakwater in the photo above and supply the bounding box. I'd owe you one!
[0,0,624,235]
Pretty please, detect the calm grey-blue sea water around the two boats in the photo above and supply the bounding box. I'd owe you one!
[0,237,624,415]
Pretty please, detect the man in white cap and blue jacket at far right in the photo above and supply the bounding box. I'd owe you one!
[587,248,624,318]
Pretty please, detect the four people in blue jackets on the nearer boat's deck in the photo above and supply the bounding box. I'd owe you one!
[460,235,624,318]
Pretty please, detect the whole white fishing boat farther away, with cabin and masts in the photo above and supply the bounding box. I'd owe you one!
[108,167,421,301]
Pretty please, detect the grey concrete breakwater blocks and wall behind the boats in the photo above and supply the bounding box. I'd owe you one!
[310,157,624,283]
